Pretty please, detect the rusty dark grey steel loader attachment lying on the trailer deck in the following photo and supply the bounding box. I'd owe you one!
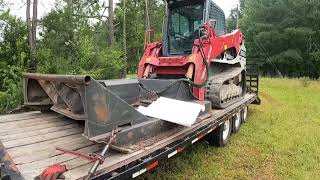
[24,74,193,145]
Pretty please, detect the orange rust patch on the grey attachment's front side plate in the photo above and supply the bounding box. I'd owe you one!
[94,96,109,123]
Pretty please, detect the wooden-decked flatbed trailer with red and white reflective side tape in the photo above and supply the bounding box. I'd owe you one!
[0,93,259,179]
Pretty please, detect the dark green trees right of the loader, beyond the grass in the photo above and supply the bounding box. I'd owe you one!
[241,0,320,78]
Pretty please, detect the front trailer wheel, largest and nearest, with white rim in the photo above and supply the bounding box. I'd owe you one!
[207,119,232,147]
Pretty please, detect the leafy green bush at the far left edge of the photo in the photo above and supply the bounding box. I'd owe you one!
[0,11,30,113]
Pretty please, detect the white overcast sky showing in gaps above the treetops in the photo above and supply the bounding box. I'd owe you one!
[5,0,239,19]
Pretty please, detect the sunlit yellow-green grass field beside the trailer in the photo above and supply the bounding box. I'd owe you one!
[140,78,320,179]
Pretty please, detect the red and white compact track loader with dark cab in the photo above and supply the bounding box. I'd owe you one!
[138,0,246,108]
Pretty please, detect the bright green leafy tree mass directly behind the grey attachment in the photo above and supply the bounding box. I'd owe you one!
[38,1,122,79]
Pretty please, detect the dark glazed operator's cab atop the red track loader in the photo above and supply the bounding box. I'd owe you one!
[162,0,225,57]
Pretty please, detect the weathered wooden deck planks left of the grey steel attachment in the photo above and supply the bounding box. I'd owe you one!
[0,112,91,179]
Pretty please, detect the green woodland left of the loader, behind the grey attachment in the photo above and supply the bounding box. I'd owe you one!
[0,0,165,112]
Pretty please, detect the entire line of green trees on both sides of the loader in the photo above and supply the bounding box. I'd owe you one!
[0,0,320,112]
